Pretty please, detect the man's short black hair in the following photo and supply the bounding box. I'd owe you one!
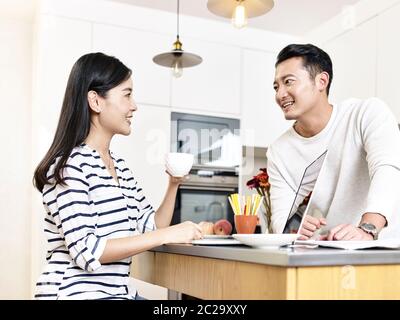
[275,44,333,95]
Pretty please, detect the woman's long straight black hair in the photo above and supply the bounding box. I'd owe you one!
[33,53,132,192]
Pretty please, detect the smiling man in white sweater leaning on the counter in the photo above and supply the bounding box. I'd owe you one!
[267,44,400,240]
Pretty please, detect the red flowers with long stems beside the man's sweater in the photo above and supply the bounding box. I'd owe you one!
[246,168,272,233]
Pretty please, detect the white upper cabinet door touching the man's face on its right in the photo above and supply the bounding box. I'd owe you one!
[241,50,290,147]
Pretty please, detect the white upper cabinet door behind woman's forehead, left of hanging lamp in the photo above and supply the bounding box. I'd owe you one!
[93,23,172,106]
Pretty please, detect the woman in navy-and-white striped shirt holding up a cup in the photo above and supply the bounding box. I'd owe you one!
[34,53,201,299]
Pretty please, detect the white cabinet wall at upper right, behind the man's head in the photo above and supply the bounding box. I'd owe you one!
[306,0,400,123]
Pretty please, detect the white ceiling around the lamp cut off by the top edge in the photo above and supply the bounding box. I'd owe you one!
[109,0,359,36]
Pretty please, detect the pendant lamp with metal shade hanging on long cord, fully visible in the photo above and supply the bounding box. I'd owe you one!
[153,0,203,78]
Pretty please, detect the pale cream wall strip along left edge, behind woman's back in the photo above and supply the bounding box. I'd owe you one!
[0,16,32,299]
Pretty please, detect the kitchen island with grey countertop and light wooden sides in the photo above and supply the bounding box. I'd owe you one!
[132,244,400,299]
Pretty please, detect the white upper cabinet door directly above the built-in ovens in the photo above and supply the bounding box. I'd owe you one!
[171,38,241,116]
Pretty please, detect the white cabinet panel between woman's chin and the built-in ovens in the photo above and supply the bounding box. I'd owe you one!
[112,105,171,209]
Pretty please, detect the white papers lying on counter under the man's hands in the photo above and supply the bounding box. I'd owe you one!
[295,238,400,250]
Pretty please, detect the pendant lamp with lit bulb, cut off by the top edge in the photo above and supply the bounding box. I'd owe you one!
[207,0,274,28]
